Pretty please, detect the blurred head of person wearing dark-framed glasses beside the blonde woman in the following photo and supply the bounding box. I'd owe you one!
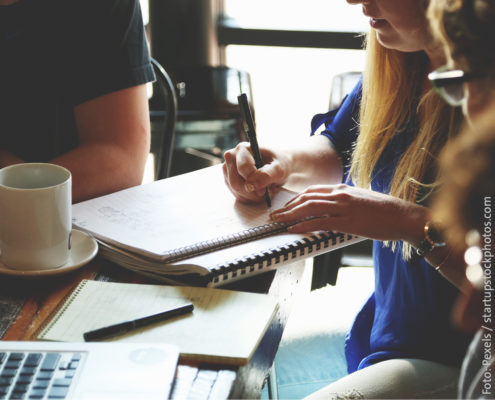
[428,0,495,121]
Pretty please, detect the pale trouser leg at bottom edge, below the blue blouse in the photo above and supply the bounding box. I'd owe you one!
[307,359,459,399]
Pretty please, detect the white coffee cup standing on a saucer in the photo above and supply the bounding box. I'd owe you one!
[0,163,72,270]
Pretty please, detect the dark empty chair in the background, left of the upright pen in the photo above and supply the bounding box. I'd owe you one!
[167,65,252,175]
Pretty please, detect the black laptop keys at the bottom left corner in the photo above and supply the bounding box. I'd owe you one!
[0,352,83,400]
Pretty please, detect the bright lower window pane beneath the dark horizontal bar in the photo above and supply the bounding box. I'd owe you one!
[226,46,364,143]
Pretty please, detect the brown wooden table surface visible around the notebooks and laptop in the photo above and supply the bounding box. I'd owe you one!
[0,257,304,399]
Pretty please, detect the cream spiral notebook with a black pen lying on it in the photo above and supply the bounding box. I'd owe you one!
[37,280,278,365]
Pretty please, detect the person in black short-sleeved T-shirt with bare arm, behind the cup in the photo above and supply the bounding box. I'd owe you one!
[0,0,154,202]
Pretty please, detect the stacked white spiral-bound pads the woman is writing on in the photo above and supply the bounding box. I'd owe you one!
[72,166,362,286]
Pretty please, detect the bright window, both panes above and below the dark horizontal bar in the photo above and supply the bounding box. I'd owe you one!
[225,0,369,143]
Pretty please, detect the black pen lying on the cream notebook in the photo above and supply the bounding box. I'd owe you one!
[83,303,194,342]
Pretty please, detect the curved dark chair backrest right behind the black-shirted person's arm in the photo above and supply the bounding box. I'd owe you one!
[150,58,177,179]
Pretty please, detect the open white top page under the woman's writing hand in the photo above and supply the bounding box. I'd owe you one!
[73,166,294,256]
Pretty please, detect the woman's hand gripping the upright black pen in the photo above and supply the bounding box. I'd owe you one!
[222,142,290,203]
